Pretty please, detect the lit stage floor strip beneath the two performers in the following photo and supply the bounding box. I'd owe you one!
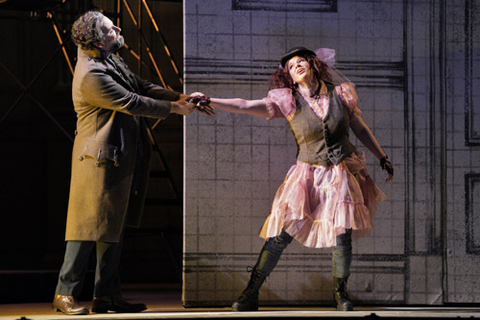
[0,291,480,320]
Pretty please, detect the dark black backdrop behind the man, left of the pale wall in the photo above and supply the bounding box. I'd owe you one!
[0,0,183,303]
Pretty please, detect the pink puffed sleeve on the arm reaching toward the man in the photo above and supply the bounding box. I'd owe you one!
[263,88,296,120]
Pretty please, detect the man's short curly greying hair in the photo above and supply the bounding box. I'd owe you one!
[72,11,104,50]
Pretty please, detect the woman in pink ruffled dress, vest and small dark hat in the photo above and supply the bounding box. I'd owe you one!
[206,47,393,311]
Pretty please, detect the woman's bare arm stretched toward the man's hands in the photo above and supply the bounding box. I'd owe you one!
[210,98,272,118]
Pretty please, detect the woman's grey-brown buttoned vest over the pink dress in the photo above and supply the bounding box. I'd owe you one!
[289,84,355,167]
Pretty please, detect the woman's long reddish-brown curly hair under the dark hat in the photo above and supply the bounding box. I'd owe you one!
[268,54,332,92]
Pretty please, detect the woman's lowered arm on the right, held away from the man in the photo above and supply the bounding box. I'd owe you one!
[350,115,393,182]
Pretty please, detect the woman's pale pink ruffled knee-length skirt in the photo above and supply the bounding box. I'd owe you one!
[260,152,386,248]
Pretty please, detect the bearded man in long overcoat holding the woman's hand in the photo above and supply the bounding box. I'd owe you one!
[53,11,211,314]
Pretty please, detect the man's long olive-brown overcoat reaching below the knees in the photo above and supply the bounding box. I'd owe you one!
[65,49,180,242]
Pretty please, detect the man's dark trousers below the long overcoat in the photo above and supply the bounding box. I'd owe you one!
[55,240,123,297]
